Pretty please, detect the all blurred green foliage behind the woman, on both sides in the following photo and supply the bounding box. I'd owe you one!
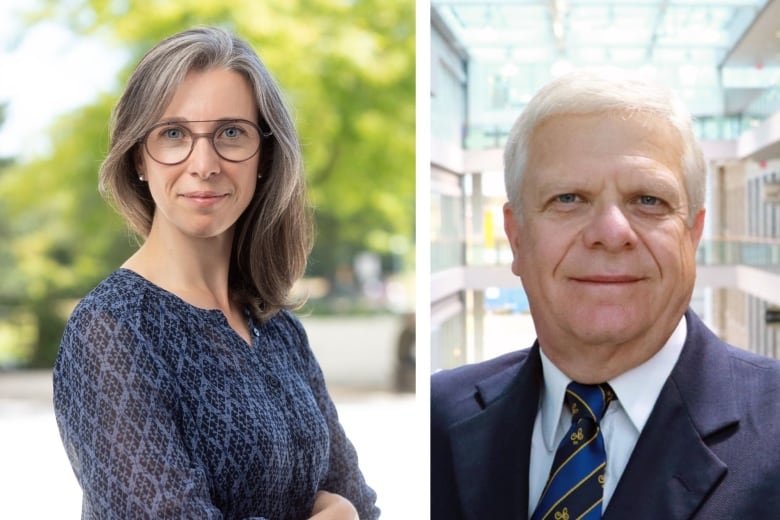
[0,0,415,365]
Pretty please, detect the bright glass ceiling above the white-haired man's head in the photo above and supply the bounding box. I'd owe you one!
[431,0,780,148]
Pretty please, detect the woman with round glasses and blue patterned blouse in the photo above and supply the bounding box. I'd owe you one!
[54,28,379,520]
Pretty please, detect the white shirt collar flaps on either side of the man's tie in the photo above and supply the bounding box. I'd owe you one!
[539,316,688,451]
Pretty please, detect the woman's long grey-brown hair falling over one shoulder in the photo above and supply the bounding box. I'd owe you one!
[100,27,312,319]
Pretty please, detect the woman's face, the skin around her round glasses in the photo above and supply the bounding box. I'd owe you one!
[138,69,260,241]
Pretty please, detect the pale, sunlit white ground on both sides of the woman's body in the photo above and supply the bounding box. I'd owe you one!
[0,372,420,520]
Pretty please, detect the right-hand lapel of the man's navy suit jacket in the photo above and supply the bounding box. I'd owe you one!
[604,312,739,520]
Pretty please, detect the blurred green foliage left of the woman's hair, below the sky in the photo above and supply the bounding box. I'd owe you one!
[0,98,133,366]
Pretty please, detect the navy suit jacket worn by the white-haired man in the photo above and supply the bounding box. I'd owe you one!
[431,311,780,520]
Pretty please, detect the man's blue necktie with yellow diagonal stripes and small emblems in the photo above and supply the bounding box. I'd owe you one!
[531,382,615,520]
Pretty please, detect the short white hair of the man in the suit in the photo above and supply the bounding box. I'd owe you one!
[504,70,706,224]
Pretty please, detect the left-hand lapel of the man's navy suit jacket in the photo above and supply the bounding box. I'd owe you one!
[450,345,542,519]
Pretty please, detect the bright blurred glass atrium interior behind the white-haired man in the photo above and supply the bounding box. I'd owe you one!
[430,0,780,370]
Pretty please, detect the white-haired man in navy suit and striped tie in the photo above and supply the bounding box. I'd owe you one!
[431,72,780,520]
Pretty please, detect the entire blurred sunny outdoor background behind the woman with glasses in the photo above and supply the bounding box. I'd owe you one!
[0,0,424,518]
